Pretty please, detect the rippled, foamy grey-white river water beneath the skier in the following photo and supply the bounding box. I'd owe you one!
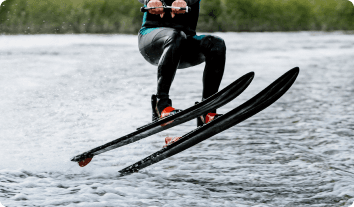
[0,32,354,207]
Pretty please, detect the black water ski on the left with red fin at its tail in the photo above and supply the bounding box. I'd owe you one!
[71,72,254,167]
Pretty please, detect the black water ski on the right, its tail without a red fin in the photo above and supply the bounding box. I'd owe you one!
[119,67,299,176]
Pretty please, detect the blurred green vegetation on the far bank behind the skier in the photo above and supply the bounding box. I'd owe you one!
[0,0,354,34]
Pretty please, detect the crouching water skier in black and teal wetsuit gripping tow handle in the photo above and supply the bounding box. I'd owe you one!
[138,0,226,146]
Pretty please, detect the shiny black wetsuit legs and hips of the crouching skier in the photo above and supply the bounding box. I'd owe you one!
[139,28,226,111]
